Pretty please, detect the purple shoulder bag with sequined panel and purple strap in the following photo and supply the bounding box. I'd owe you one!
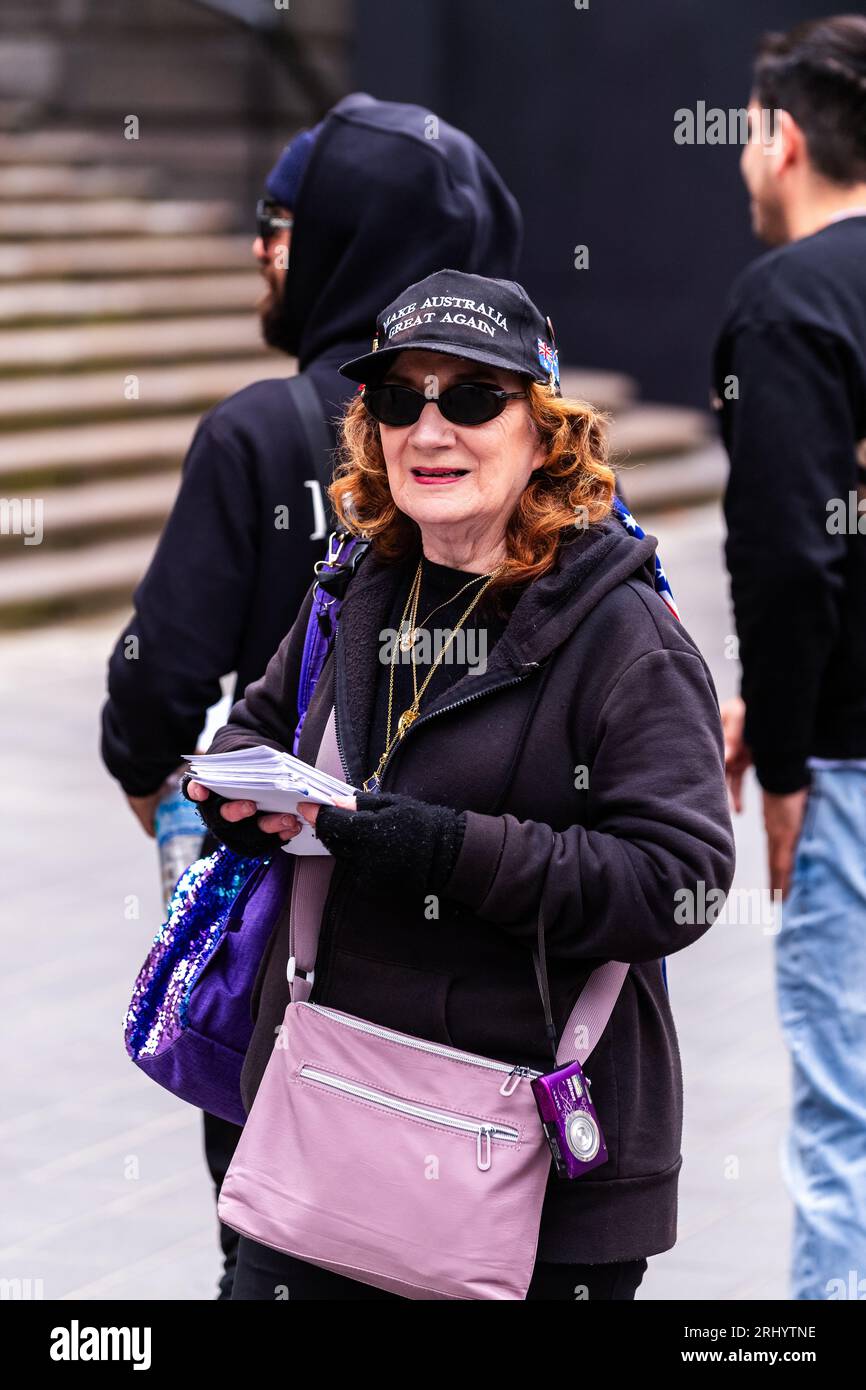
[124,532,366,1125]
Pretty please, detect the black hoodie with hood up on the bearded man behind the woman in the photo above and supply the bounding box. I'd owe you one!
[101,93,521,795]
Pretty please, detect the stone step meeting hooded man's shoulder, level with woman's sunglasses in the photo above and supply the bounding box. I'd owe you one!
[0,357,284,431]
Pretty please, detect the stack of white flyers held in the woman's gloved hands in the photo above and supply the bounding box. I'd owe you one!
[185,744,354,855]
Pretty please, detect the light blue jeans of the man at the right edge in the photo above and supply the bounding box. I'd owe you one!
[776,766,866,1300]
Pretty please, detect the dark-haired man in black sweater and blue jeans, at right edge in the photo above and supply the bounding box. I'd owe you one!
[714,15,866,1298]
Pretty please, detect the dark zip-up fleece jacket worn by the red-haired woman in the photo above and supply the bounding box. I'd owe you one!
[200,523,734,1262]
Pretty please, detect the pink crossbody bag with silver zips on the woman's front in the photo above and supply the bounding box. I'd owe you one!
[218,713,628,1300]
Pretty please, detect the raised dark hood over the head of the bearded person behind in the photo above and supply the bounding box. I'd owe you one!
[284,92,523,368]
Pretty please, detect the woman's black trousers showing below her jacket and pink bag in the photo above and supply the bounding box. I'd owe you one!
[232,1236,646,1302]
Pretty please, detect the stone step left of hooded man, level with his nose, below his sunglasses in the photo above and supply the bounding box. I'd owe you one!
[0,227,253,281]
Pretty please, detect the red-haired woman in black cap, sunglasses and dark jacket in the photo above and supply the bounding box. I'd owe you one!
[188,271,734,1300]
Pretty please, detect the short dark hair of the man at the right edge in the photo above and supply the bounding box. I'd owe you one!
[753,14,866,183]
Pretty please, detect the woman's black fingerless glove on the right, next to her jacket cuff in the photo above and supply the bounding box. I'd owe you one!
[316,791,466,892]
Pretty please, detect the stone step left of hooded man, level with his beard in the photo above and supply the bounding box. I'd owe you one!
[0,270,263,323]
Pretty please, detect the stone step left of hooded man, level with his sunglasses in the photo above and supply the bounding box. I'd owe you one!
[0,197,235,239]
